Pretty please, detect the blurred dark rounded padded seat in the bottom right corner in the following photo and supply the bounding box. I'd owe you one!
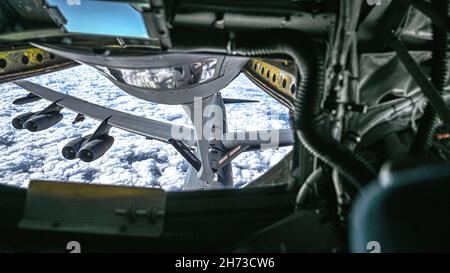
[349,164,450,252]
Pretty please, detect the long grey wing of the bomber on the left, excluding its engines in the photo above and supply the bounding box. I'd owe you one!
[15,81,195,146]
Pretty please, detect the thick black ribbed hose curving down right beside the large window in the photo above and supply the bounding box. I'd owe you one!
[232,30,376,188]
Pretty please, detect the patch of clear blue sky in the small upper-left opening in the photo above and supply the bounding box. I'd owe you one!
[47,0,148,38]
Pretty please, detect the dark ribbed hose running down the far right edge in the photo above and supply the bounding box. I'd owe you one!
[410,0,449,156]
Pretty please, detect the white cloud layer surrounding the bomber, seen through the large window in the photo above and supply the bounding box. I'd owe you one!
[0,65,291,191]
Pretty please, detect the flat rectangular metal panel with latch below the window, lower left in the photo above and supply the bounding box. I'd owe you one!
[19,178,166,237]
